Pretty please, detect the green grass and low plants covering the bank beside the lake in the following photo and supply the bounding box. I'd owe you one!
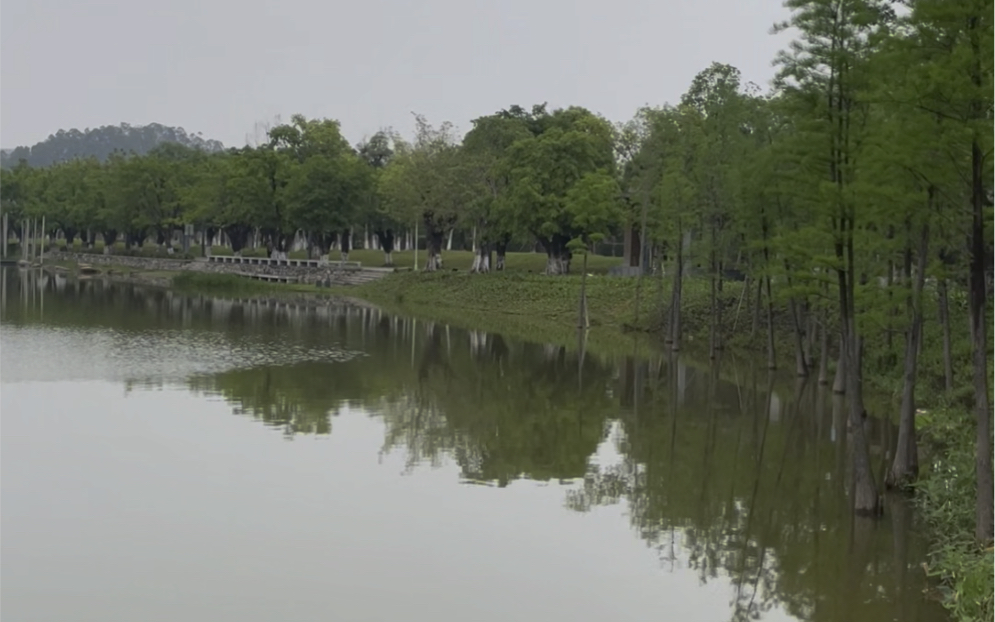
[15,244,993,619]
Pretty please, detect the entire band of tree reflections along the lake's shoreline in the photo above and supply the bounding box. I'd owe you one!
[2,270,944,622]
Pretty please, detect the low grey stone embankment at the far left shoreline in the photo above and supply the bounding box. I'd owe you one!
[46,252,393,287]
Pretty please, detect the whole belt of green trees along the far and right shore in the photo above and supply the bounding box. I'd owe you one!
[0,0,993,541]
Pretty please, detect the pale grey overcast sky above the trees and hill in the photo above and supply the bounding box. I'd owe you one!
[0,0,788,147]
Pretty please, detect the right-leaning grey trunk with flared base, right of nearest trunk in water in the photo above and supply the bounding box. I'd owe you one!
[884,225,929,488]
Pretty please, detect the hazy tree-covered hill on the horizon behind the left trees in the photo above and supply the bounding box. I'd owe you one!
[0,123,224,168]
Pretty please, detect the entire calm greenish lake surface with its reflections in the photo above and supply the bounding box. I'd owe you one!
[0,269,944,622]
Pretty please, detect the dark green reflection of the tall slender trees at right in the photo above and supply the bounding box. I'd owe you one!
[566,360,936,620]
